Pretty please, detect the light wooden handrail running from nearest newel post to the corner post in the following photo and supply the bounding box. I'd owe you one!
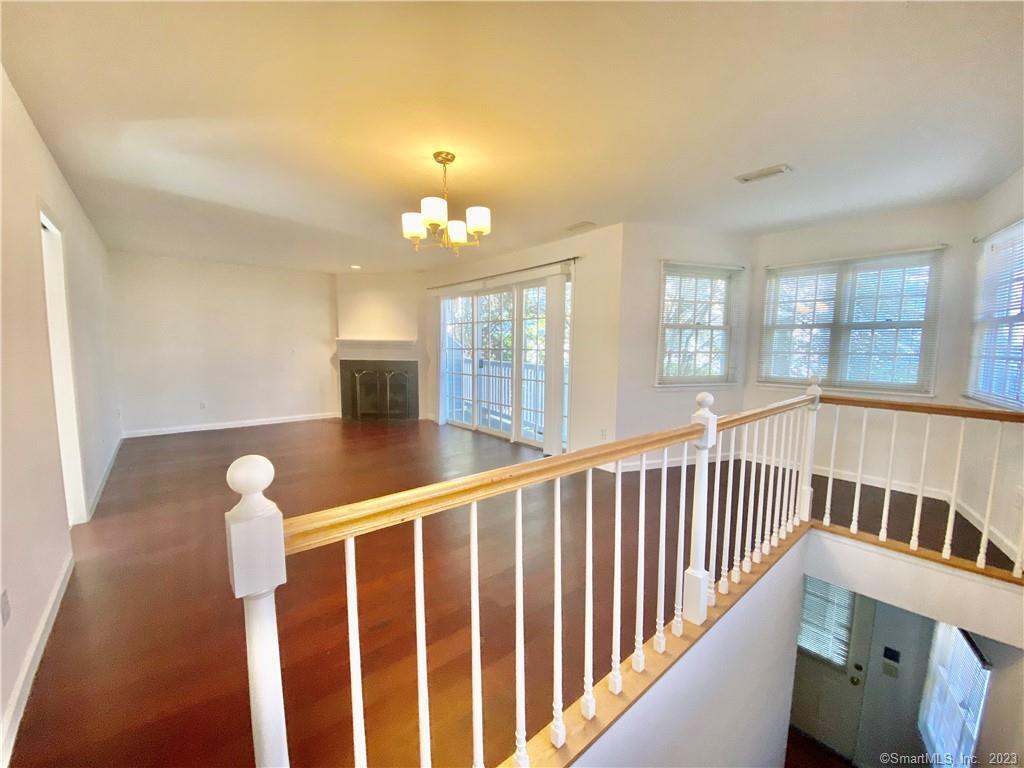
[285,395,814,555]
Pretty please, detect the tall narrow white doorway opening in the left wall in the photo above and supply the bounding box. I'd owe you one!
[39,213,89,525]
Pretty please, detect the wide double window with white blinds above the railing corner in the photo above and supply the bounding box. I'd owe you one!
[759,251,939,392]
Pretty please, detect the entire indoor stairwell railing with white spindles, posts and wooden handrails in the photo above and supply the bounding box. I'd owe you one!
[226,380,1024,766]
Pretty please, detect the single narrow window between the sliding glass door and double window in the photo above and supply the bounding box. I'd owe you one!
[655,261,732,386]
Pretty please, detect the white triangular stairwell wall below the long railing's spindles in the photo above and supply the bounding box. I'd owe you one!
[574,540,806,768]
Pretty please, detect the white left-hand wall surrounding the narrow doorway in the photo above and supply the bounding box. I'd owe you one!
[0,73,120,757]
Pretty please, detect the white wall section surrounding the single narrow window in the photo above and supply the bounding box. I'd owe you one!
[614,222,752,438]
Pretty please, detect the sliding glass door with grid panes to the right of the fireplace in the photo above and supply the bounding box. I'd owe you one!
[440,280,569,453]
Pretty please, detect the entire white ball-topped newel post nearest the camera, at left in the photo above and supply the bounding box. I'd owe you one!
[224,456,288,768]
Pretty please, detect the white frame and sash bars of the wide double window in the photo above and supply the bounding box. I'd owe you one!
[755,252,946,398]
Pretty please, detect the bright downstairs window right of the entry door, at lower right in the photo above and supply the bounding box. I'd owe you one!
[918,624,990,765]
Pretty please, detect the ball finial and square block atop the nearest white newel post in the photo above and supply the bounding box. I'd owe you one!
[224,455,287,597]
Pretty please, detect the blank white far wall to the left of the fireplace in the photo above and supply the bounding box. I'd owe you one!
[114,254,340,435]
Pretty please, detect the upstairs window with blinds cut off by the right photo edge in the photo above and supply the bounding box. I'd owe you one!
[968,221,1024,410]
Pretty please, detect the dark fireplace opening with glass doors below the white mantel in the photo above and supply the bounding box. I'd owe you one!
[340,359,420,421]
